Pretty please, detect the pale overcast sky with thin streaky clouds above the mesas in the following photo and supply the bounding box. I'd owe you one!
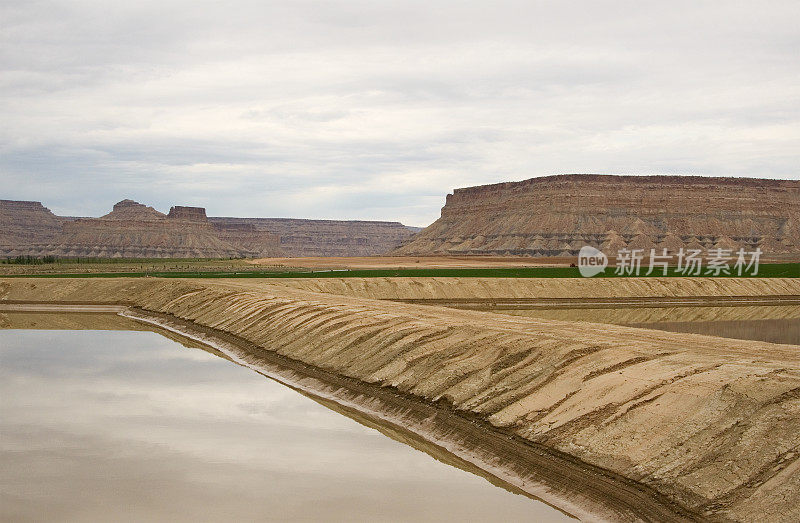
[0,0,800,226]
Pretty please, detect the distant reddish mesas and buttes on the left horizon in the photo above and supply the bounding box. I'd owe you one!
[0,200,416,258]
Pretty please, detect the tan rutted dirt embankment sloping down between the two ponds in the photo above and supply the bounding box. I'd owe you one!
[0,279,800,521]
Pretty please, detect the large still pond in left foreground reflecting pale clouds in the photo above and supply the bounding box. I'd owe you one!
[0,314,568,521]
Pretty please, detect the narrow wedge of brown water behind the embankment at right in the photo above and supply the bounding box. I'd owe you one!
[495,305,800,345]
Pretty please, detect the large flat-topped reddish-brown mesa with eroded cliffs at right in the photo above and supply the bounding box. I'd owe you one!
[395,174,800,256]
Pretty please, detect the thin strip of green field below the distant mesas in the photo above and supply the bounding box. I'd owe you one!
[0,263,800,278]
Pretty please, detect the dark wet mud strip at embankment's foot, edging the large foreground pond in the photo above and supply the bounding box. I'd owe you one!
[119,307,701,521]
